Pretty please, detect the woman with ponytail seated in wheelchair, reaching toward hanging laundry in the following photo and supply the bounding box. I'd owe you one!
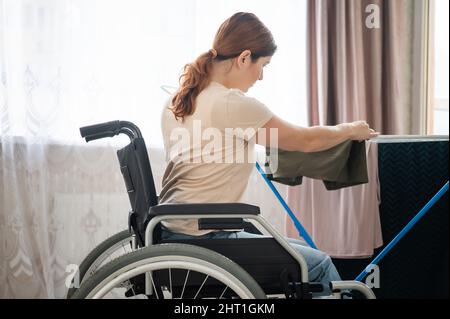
[160,12,378,293]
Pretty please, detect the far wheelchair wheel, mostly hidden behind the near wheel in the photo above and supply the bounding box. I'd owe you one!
[67,229,132,298]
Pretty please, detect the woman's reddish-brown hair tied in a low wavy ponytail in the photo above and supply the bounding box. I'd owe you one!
[171,12,277,120]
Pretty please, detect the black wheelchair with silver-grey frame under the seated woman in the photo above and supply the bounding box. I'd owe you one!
[67,121,375,299]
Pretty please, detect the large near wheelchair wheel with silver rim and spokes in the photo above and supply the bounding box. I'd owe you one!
[72,244,266,299]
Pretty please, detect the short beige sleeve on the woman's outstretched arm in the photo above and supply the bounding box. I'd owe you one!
[216,90,273,140]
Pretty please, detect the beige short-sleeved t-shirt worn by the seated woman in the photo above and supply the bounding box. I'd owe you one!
[160,82,273,236]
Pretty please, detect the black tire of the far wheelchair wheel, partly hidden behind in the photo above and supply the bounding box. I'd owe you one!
[67,229,132,299]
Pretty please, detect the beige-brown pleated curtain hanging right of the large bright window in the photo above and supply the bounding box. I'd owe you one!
[308,0,427,134]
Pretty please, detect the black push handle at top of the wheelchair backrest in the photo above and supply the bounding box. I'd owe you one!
[80,121,142,142]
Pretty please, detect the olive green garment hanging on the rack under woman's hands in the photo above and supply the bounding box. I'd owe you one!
[265,141,369,190]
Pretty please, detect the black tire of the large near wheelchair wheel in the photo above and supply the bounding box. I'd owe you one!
[72,244,266,299]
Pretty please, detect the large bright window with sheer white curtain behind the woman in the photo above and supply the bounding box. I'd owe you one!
[0,0,307,146]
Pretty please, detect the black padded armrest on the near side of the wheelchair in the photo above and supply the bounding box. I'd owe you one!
[149,203,260,216]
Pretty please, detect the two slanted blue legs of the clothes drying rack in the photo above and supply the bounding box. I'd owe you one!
[256,162,449,281]
